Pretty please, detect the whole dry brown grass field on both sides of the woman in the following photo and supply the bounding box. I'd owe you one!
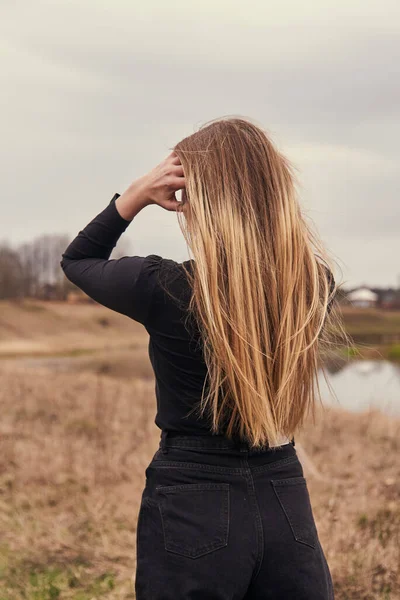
[0,303,400,600]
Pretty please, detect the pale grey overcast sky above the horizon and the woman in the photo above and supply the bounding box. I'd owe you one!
[0,0,400,287]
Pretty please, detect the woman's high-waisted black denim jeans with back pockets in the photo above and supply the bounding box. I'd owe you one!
[135,431,334,600]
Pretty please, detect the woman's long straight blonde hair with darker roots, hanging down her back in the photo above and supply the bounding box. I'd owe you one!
[174,117,347,448]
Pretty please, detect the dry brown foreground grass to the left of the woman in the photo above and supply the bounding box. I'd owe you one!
[0,369,158,600]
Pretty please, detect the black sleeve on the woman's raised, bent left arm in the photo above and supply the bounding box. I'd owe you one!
[60,193,163,326]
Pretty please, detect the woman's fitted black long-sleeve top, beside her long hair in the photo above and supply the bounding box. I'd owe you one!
[60,193,334,434]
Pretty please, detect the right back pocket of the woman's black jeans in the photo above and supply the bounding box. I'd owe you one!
[271,477,318,548]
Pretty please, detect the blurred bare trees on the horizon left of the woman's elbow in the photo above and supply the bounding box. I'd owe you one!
[0,234,129,300]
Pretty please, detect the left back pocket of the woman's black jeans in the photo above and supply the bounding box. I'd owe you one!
[156,482,230,558]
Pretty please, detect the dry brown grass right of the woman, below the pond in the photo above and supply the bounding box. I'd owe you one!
[299,400,400,600]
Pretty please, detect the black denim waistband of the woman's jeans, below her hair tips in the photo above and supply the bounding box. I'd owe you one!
[160,430,295,455]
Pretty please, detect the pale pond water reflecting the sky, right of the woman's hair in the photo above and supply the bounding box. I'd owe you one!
[318,360,400,416]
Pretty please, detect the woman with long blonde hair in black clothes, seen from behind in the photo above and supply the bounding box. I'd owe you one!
[61,117,343,600]
